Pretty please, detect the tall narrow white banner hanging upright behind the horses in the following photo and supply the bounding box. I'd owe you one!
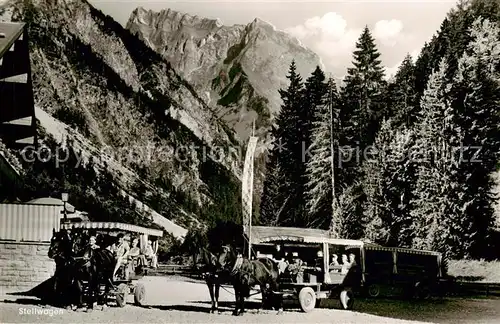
[241,136,258,232]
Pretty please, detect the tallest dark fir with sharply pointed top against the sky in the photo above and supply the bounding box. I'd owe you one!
[339,27,386,238]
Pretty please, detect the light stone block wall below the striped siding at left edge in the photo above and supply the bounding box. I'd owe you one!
[0,241,55,294]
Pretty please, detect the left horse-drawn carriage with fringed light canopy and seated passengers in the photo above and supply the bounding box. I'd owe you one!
[56,222,163,307]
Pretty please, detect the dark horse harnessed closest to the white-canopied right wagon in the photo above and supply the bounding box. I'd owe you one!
[218,246,283,315]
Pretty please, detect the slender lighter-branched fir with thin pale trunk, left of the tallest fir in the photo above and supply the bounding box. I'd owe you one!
[306,79,339,228]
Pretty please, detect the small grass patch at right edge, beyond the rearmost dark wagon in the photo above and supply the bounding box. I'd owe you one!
[448,260,500,283]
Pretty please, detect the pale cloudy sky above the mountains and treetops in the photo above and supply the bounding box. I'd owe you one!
[89,0,456,77]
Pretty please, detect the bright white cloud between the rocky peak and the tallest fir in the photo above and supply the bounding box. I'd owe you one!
[285,12,362,74]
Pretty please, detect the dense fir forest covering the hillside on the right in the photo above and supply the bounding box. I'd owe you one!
[259,0,500,258]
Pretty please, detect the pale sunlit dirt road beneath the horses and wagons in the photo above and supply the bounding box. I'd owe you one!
[0,277,500,324]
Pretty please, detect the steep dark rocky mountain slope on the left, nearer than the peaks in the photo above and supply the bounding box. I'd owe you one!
[1,0,241,234]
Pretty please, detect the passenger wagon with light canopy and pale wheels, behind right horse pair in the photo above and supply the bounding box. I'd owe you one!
[252,226,363,312]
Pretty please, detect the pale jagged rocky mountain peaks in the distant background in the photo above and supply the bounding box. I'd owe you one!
[126,7,323,142]
